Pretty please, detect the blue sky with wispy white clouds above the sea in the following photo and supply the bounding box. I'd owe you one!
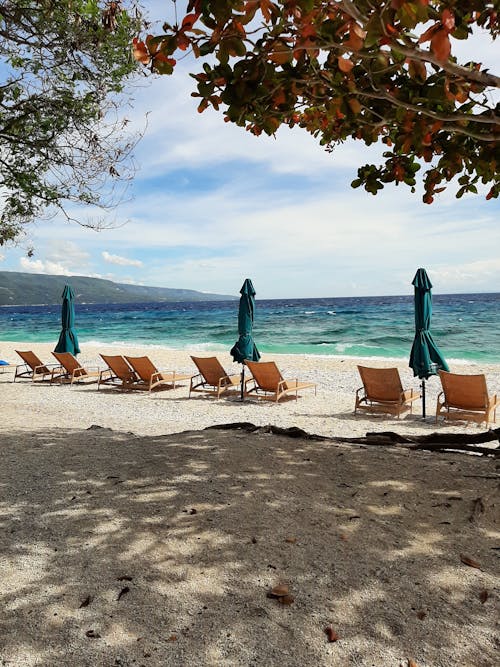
[0,0,500,299]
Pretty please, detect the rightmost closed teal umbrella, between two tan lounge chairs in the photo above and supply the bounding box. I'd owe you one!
[410,269,450,417]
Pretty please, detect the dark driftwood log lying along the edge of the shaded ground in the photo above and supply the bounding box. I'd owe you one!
[206,422,500,457]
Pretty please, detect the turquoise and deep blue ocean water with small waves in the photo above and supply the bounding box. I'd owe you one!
[0,294,500,364]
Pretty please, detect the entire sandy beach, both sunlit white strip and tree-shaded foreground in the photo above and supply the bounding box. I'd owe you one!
[0,342,500,667]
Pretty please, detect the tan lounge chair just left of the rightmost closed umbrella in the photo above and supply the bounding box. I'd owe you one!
[354,366,422,419]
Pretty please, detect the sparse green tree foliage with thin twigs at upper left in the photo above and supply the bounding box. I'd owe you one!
[0,0,145,245]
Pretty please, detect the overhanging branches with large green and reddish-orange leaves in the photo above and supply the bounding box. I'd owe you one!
[134,0,500,203]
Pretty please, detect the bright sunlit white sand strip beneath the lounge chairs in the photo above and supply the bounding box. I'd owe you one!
[0,342,500,436]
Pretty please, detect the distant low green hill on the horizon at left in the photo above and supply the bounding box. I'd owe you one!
[0,271,237,306]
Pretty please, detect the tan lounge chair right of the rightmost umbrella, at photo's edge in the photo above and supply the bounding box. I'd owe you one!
[436,371,500,424]
